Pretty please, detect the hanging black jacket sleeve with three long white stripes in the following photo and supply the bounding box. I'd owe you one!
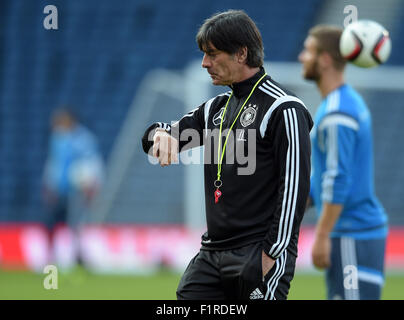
[263,104,313,270]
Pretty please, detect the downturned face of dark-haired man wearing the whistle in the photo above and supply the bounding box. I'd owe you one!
[202,44,241,86]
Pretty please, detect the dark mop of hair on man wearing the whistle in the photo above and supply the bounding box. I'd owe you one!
[196,10,264,68]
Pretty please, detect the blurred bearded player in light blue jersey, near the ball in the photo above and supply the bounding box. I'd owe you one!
[299,25,387,300]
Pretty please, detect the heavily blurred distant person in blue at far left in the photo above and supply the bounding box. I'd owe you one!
[42,108,104,267]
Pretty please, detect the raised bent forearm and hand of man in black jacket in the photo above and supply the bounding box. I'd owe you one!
[142,104,204,166]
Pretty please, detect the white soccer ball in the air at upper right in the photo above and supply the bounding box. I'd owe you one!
[339,20,391,68]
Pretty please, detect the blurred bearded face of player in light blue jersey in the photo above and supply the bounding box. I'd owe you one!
[299,36,321,81]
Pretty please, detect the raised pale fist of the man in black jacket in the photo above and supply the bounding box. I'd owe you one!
[153,129,178,167]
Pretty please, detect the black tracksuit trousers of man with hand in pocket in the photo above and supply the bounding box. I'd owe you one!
[177,243,296,300]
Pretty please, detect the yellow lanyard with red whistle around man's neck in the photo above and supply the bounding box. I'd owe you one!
[214,73,267,203]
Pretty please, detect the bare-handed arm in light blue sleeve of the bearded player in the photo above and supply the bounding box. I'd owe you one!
[312,113,359,269]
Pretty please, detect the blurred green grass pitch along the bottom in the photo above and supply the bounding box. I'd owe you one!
[0,269,404,300]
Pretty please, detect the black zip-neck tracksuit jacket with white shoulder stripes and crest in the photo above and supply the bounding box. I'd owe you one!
[142,68,313,259]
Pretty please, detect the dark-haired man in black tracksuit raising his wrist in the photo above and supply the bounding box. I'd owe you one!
[142,10,313,299]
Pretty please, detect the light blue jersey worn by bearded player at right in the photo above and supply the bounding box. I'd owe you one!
[310,84,387,239]
